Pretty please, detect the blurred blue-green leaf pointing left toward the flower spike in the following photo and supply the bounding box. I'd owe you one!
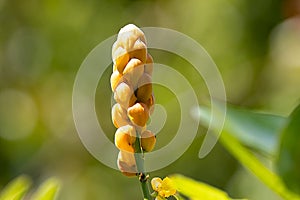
[195,106,287,156]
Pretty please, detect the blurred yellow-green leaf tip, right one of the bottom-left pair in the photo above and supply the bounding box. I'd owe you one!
[32,178,60,200]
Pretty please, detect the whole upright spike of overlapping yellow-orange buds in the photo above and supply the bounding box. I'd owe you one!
[110,24,156,176]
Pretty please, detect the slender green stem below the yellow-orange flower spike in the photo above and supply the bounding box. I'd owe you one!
[134,130,152,200]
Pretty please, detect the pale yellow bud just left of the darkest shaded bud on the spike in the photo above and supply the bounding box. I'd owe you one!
[114,82,134,109]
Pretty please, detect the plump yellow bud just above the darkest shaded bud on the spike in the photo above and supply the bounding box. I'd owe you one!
[123,58,144,89]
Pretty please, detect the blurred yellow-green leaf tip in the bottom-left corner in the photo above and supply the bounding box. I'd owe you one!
[0,175,31,200]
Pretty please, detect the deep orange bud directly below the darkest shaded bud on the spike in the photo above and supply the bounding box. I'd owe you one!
[127,103,149,127]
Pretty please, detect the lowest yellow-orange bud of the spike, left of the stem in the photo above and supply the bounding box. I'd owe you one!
[117,151,137,177]
